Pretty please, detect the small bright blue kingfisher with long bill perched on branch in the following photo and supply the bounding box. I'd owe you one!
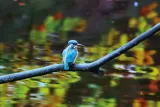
[62,40,84,70]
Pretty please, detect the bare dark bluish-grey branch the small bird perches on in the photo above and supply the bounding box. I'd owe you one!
[0,24,160,83]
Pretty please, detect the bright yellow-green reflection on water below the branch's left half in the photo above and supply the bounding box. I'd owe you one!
[0,72,80,107]
